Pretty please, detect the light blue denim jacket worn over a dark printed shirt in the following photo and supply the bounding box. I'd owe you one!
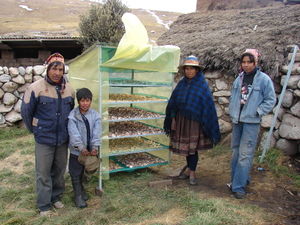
[229,70,276,123]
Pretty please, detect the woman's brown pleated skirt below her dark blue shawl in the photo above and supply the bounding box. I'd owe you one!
[170,113,213,156]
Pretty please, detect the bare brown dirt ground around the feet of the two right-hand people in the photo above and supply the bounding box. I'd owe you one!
[154,152,300,225]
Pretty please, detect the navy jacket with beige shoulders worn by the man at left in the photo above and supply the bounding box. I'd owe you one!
[21,79,74,146]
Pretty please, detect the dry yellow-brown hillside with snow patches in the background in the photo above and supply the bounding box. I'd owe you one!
[0,0,180,40]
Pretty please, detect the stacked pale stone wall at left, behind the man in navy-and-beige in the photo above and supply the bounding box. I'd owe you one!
[0,65,68,126]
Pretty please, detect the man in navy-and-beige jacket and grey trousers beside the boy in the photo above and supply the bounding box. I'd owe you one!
[21,53,74,216]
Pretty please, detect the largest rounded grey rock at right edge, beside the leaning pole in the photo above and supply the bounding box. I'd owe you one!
[279,114,300,140]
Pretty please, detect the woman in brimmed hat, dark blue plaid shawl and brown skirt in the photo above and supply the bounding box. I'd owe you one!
[164,55,220,185]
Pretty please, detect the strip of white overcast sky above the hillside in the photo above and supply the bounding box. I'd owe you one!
[122,0,197,13]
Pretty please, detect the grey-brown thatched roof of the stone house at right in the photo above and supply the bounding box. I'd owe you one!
[158,5,300,77]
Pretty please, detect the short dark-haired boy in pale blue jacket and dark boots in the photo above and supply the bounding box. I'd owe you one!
[68,88,101,208]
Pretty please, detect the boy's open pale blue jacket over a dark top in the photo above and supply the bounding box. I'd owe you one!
[68,107,101,155]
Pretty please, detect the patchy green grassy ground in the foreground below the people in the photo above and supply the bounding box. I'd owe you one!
[0,128,298,225]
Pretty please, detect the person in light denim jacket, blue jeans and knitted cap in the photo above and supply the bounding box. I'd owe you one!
[229,49,276,199]
